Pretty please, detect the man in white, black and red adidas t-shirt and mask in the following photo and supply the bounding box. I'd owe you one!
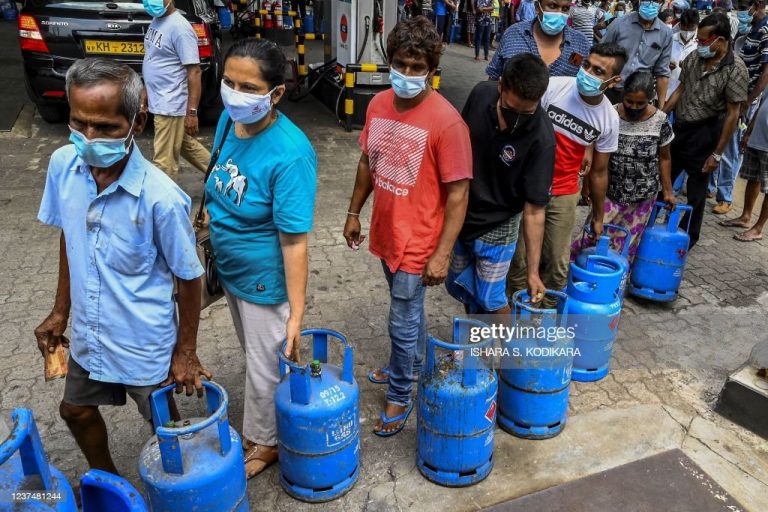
[507,43,627,307]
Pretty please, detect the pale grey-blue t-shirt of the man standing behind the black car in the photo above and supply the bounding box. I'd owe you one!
[142,11,200,116]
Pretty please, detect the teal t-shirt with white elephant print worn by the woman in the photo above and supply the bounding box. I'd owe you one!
[205,111,317,304]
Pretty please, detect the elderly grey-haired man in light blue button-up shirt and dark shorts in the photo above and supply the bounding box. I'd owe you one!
[35,59,211,473]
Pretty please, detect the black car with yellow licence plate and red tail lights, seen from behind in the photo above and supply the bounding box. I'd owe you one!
[19,0,223,124]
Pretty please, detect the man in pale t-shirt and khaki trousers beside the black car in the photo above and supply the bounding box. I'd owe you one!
[142,0,211,181]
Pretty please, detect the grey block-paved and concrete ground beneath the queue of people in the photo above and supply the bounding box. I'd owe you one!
[0,32,768,511]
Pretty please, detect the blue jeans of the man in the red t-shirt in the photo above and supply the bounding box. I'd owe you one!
[382,261,427,406]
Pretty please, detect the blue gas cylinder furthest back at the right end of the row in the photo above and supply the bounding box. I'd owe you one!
[629,202,693,302]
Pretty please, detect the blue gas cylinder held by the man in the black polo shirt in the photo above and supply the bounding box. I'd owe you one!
[499,290,574,439]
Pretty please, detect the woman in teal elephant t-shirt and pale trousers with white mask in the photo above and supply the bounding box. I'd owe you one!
[205,39,317,478]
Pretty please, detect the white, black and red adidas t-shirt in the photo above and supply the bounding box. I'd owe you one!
[541,77,619,196]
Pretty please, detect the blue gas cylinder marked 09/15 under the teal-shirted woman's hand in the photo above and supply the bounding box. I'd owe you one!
[275,329,360,502]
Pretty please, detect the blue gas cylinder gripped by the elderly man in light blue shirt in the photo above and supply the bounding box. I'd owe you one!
[139,382,248,512]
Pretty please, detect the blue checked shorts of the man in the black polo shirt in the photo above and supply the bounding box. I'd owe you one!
[445,214,522,313]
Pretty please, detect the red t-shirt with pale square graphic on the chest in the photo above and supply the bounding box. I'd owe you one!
[360,89,472,274]
